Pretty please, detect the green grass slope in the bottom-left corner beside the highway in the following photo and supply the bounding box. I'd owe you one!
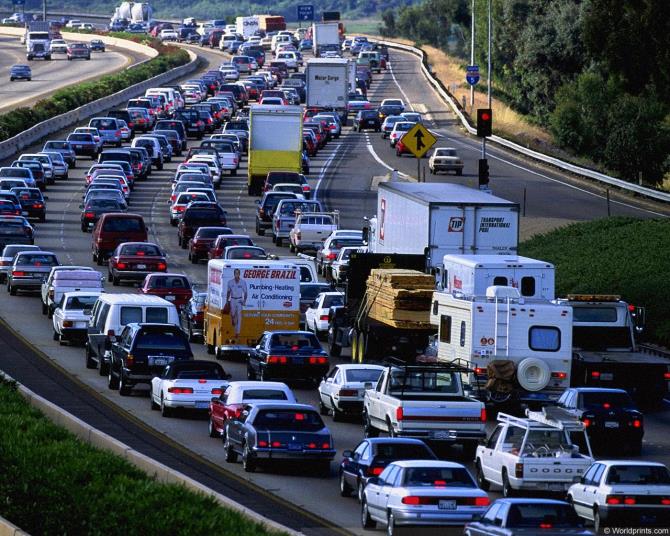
[0,379,286,536]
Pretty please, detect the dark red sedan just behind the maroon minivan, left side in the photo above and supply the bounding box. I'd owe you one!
[107,242,167,286]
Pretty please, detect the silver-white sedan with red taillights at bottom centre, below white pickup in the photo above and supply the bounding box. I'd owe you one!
[361,460,491,534]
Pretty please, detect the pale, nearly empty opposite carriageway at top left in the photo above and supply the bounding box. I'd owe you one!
[0,34,146,113]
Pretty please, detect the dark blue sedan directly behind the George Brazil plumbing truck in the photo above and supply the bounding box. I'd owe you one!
[247,331,329,383]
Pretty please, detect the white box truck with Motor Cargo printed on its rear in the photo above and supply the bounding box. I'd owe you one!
[305,58,349,124]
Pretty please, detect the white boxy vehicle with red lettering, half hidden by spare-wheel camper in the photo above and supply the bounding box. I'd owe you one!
[436,255,556,300]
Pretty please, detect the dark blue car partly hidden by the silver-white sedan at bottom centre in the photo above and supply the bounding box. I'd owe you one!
[340,437,438,501]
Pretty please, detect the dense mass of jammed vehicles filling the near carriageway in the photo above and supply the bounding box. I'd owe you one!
[0,12,670,535]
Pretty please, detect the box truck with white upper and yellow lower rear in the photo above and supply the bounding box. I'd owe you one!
[247,104,302,195]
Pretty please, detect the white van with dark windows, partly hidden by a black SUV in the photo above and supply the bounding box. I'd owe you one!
[86,294,179,376]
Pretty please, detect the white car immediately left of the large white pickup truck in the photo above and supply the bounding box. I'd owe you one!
[319,365,384,421]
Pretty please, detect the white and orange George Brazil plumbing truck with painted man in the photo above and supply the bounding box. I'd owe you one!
[204,259,300,359]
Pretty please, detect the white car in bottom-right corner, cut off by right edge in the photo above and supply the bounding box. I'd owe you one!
[568,460,670,534]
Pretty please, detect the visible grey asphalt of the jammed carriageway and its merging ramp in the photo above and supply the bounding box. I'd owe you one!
[0,38,670,534]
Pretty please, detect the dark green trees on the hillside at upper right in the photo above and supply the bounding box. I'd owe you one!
[380,0,670,184]
